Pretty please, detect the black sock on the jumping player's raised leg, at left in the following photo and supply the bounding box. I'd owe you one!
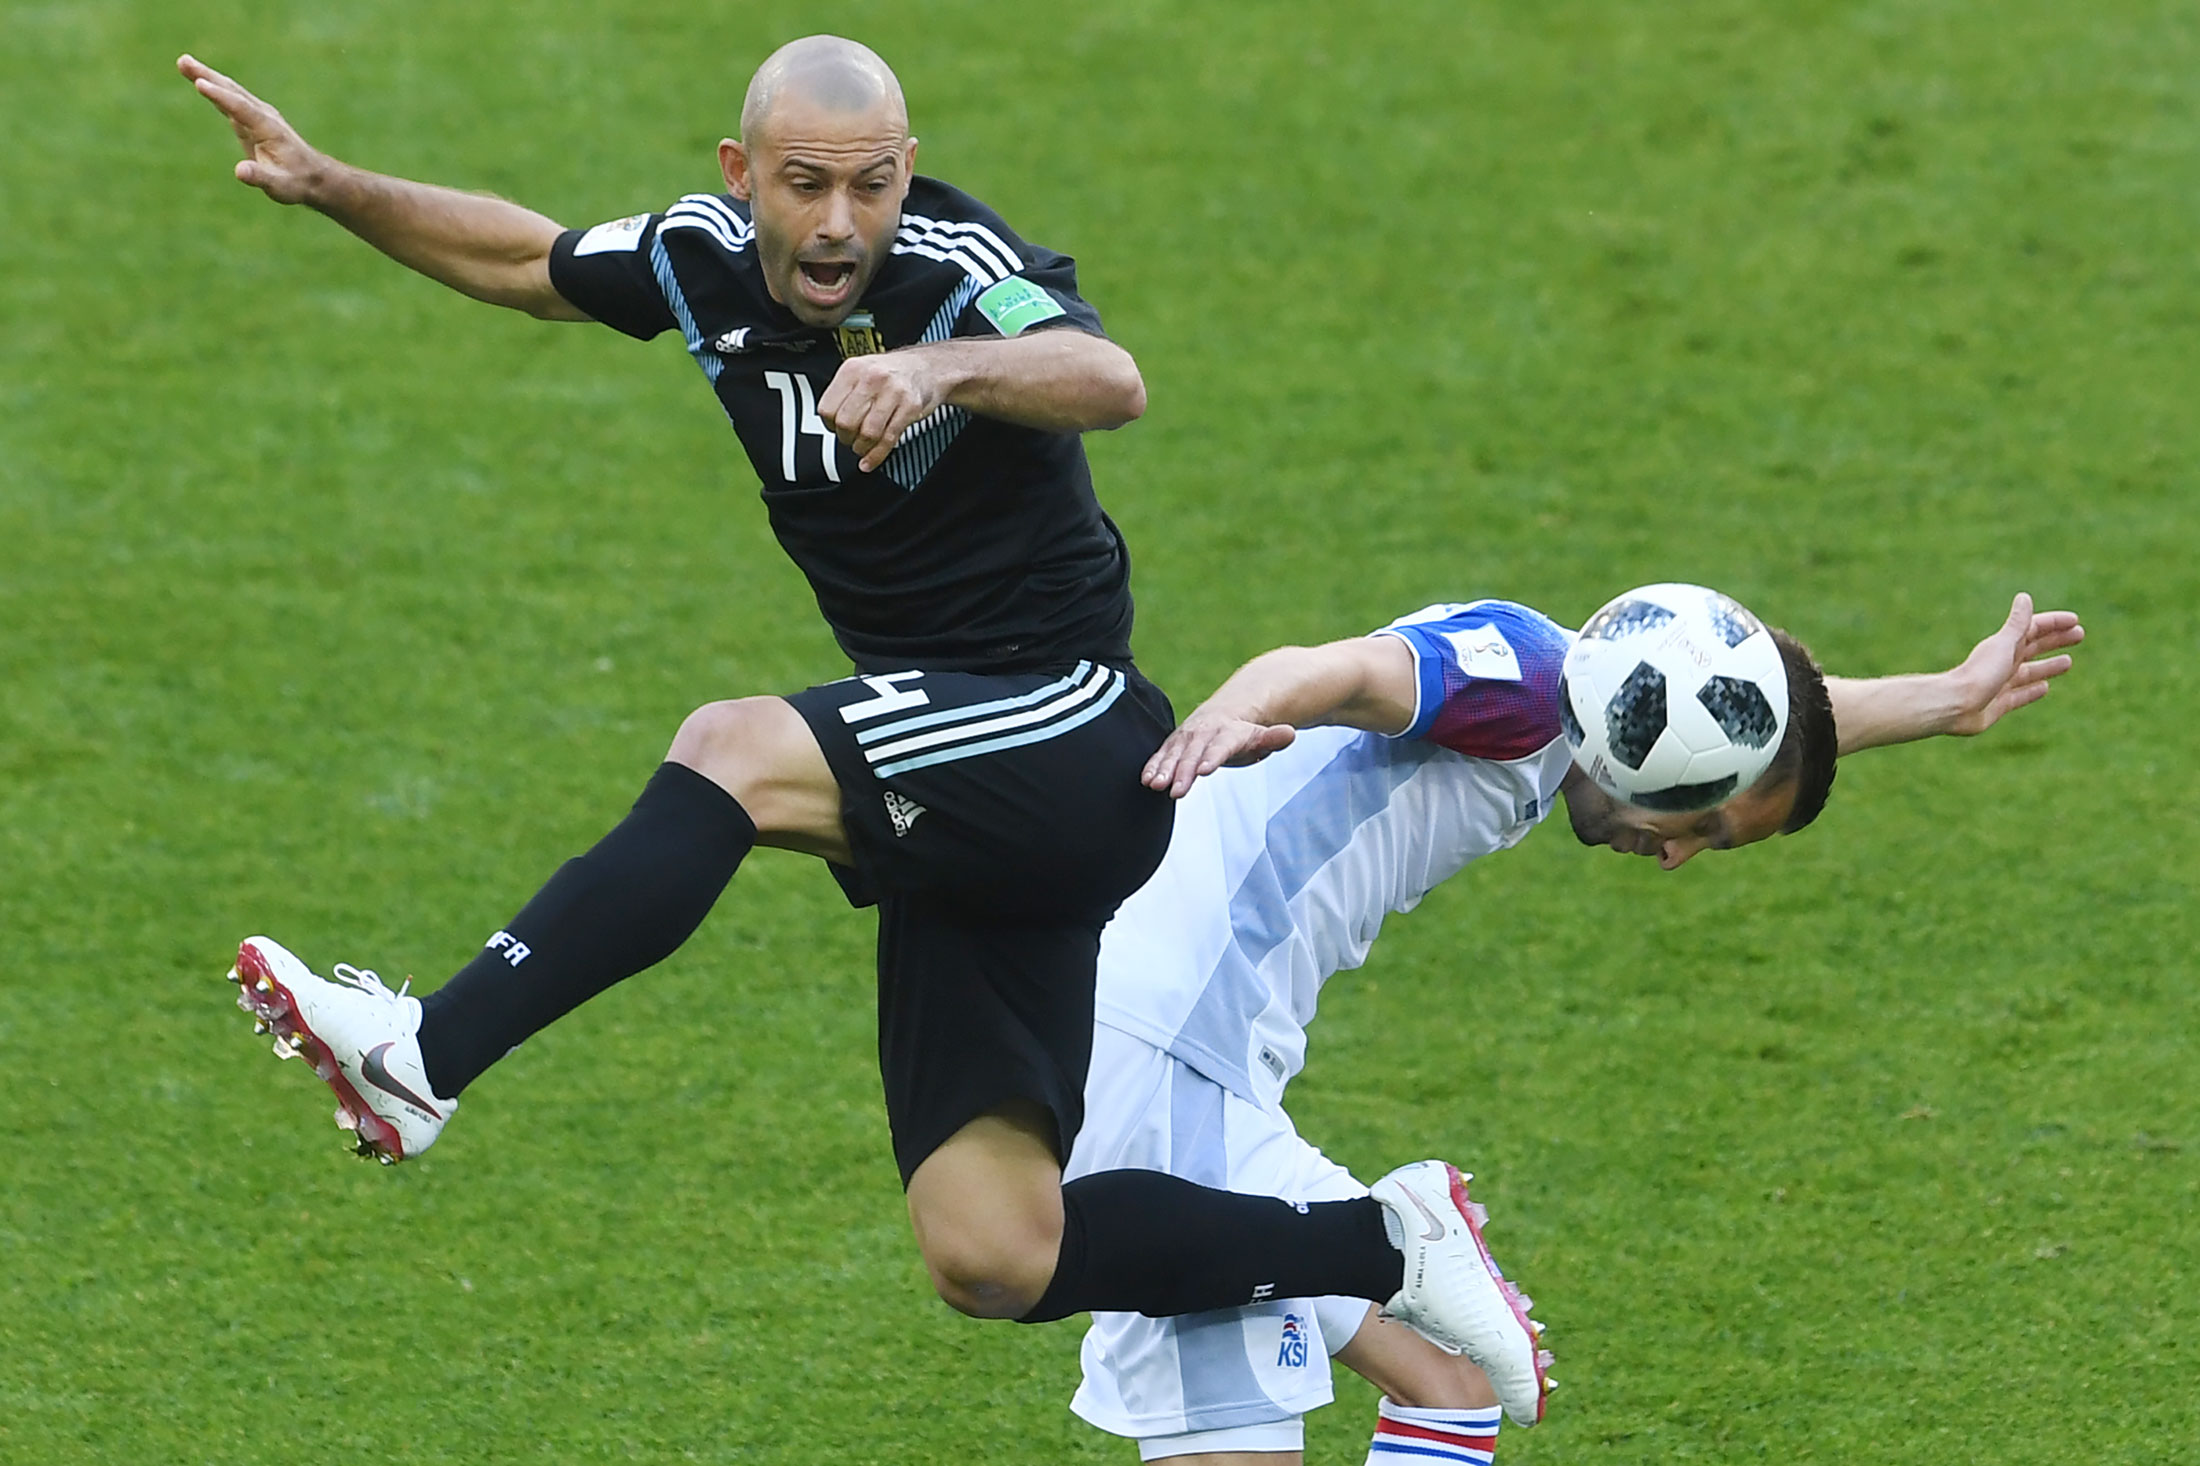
[420,764,757,1098]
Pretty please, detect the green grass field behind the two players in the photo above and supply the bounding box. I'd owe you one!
[0,0,2200,1466]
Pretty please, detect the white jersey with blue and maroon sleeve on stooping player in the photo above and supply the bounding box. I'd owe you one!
[1096,601,1573,1105]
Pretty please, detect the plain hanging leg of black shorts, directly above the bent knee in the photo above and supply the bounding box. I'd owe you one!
[878,894,1100,1186]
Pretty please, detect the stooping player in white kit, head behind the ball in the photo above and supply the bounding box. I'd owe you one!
[1067,597,2083,1466]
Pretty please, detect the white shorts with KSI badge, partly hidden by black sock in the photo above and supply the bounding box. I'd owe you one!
[1065,1024,1371,1462]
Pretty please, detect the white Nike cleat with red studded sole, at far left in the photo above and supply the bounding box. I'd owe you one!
[229,938,458,1167]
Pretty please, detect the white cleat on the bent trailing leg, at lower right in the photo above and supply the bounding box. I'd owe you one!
[1368,1160,1551,1426]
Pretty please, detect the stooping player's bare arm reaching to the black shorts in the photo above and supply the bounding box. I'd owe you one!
[1144,636,1415,799]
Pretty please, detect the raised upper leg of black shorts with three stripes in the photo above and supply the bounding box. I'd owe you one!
[790,663,1173,920]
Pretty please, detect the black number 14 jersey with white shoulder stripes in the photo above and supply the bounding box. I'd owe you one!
[550,178,1131,671]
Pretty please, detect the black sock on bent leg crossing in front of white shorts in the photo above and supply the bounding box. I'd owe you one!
[1023,1171,1406,1323]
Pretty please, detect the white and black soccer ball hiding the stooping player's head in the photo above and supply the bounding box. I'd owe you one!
[1558,586,1786,812]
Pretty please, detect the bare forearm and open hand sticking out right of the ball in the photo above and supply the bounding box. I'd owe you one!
[1826,592,2086,755]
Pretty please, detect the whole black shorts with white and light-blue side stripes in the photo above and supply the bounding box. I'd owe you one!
[790,663,1175,1184]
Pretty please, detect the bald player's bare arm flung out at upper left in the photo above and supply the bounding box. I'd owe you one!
[176,55,590,321]
